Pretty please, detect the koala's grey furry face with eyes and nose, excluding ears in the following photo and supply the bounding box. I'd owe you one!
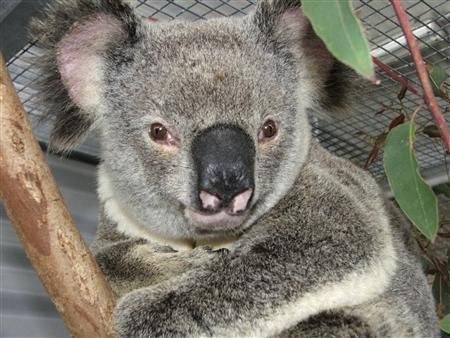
[100,20,309,236]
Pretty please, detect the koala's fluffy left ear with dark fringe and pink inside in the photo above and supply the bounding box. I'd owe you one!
[31,0,141,151]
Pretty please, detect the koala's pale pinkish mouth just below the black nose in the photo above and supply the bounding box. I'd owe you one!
[184,208,247,231]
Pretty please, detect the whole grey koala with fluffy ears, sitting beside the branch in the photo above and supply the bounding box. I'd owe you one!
[31,0,439,337]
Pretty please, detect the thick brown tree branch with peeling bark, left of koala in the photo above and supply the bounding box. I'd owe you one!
[0,53,115,338]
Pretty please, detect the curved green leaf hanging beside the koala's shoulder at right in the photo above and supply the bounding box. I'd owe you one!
[383,121,439,240]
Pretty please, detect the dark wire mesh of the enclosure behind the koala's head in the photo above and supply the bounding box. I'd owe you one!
[4,0,450,177]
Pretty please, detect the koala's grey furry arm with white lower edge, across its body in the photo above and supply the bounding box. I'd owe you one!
[115,162,395,337]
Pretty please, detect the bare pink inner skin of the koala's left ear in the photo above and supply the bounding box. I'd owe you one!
[56,15,124,111]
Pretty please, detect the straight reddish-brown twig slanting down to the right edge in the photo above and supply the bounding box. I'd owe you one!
[391,0,450,153]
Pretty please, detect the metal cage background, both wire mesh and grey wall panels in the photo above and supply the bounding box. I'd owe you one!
[0,0,450,337]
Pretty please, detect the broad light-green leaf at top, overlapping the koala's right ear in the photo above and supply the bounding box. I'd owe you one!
[302,0,374,78]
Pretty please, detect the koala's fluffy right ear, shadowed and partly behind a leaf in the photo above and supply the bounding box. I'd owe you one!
[253,0,360,118]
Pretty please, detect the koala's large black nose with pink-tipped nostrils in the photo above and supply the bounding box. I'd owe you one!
[192,125,255,213]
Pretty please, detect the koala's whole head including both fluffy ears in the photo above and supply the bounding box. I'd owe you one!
[33,0,356,238]
